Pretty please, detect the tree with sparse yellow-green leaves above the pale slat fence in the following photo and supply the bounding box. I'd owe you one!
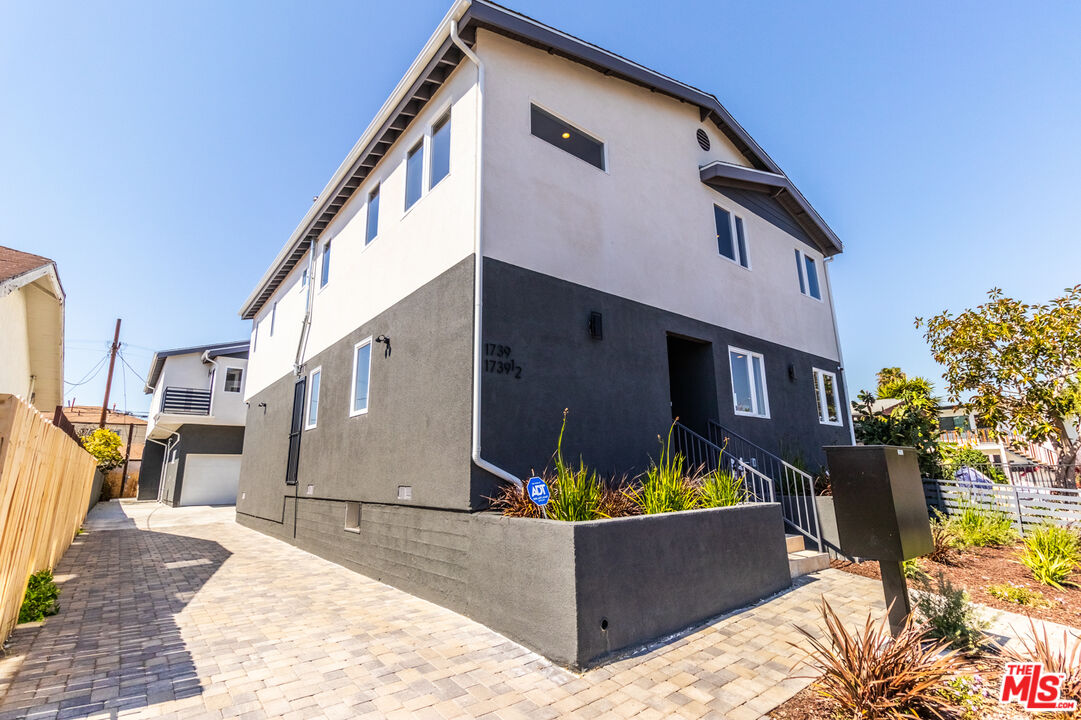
[916,285,1081,486]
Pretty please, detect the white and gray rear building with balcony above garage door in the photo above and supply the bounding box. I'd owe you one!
[138,341,248,506]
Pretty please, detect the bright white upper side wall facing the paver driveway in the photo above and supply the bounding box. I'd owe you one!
[245,62,477,398]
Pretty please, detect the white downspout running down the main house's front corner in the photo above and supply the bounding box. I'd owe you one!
[451,19,522,488]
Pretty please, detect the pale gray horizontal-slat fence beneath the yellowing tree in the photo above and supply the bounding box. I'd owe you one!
[923,478,1081,534]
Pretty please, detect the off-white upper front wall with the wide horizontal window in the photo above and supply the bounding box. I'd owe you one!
[478,30,838,359]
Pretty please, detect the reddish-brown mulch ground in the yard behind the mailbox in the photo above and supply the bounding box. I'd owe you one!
[830,545,1081,627]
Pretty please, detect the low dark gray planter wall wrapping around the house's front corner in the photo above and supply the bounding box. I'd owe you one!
[237,495,791,667]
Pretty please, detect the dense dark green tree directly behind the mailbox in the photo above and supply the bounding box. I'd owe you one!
[852,368,942,477]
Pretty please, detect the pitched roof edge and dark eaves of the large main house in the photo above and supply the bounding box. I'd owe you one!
[240,0,841,320]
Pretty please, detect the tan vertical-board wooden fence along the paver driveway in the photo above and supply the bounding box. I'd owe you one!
[0,395,96,643]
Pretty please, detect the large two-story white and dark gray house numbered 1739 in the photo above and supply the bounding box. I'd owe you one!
[237,1,852,627]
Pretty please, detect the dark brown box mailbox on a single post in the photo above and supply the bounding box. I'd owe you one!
[825,445,933,635]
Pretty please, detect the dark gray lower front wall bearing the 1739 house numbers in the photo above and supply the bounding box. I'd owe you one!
[481,258,850,477]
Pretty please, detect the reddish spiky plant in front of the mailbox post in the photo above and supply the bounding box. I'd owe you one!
[797,599,963,720]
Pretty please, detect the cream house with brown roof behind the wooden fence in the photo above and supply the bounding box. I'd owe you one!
[0,246,64,408]
